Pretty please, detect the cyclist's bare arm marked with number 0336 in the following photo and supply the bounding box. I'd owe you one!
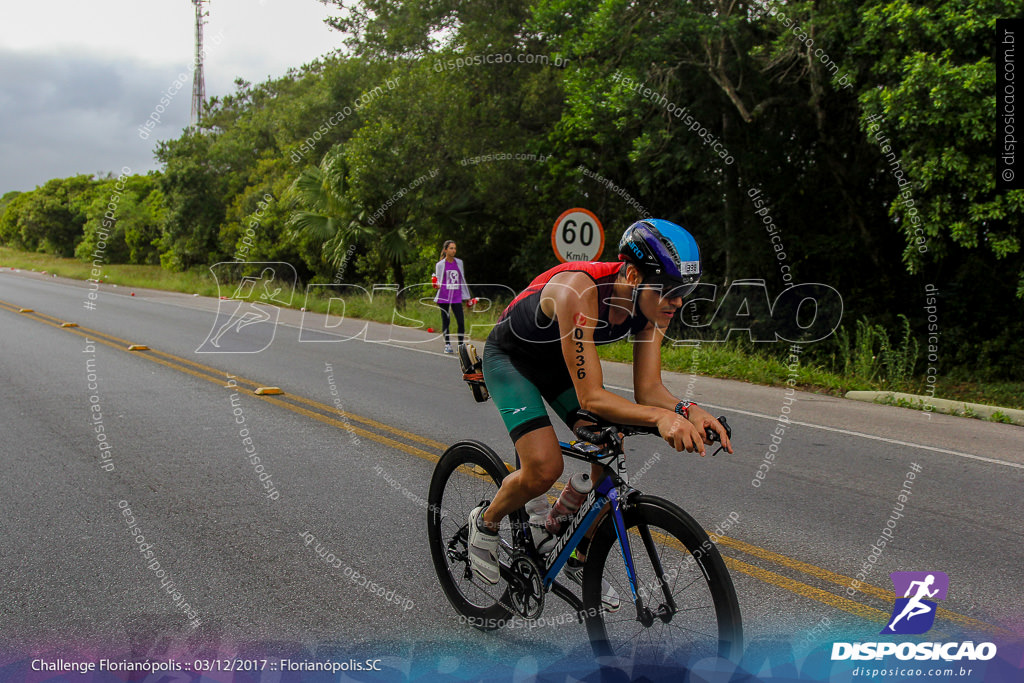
[541,272,703,454]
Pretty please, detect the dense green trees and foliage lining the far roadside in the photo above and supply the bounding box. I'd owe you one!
[0,0,1024,378]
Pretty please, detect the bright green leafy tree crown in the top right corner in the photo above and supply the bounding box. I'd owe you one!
[854,0,1024,282]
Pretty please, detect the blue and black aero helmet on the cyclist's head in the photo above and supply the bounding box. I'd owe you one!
[618,218,700,296]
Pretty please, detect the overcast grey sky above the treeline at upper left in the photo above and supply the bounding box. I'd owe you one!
[0,0,342,195]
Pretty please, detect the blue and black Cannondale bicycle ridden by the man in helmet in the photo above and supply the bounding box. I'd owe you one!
[427,411,742,665]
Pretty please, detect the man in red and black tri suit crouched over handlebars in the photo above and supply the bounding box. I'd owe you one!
[469,219,732,589]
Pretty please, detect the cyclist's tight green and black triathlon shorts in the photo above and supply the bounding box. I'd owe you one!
[483,343,580,443]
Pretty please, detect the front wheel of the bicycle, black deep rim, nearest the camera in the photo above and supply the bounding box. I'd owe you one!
[583,496,743,667]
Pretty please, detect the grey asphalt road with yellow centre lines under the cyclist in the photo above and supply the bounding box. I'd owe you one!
[0,269,1024,678]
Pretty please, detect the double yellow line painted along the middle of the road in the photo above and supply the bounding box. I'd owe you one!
[0,300,1017,637]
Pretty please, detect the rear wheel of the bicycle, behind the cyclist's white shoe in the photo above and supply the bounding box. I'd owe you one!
[427,440,512,631]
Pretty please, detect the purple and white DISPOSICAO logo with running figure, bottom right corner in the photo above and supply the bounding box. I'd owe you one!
[831,571,996,661]
